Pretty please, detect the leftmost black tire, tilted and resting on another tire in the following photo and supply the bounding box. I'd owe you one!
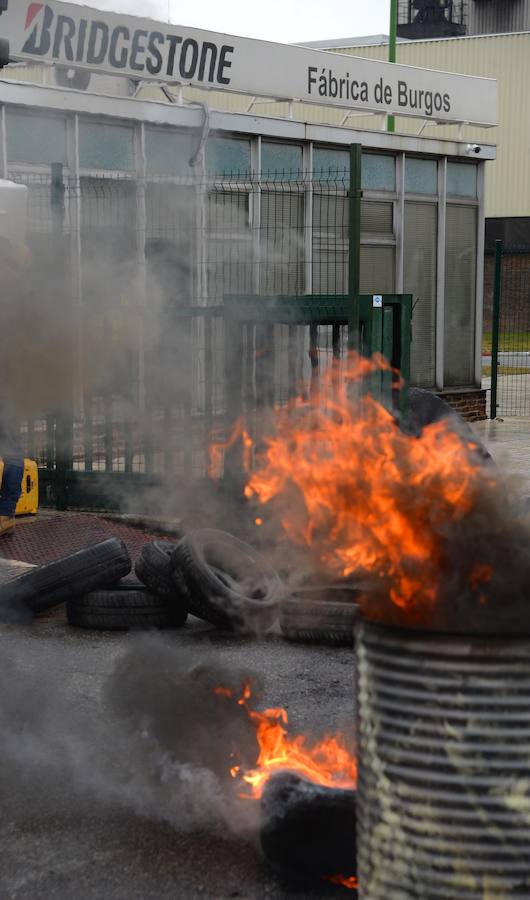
[0,538,131,618]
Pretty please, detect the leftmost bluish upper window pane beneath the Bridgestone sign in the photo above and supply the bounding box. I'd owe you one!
[6,109,66,166]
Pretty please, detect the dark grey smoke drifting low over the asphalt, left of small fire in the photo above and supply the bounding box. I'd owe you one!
[0,637,257,834]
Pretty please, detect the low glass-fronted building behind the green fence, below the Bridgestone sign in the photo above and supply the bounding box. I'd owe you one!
[0,0,496,479]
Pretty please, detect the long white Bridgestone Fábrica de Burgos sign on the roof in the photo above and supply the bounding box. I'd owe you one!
[4,0,498,126]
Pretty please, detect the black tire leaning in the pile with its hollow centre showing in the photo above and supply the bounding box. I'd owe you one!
[172,528,282,633]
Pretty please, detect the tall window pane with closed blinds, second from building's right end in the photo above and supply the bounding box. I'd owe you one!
[403,202,438,387]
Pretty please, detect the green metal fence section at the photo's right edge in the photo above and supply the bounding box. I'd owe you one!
[488,241,530,419]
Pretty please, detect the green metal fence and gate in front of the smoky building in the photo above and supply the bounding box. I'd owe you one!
[5,146,411,510]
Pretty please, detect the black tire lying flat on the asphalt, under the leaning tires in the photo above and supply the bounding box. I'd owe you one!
[66,579,187,631]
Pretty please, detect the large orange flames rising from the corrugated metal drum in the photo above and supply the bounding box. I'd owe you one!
[238,355,487,612]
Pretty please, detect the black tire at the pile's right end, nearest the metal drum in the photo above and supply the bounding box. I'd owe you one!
[280,585,361,647]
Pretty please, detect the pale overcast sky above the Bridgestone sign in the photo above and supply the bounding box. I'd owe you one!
[67,0,390,43]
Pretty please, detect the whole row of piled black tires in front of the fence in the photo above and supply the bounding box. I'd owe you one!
[0,528,359,645]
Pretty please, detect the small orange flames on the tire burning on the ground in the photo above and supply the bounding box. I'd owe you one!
[215,684,357,800]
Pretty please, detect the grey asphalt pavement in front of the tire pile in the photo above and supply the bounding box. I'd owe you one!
[0,615,354,900]
